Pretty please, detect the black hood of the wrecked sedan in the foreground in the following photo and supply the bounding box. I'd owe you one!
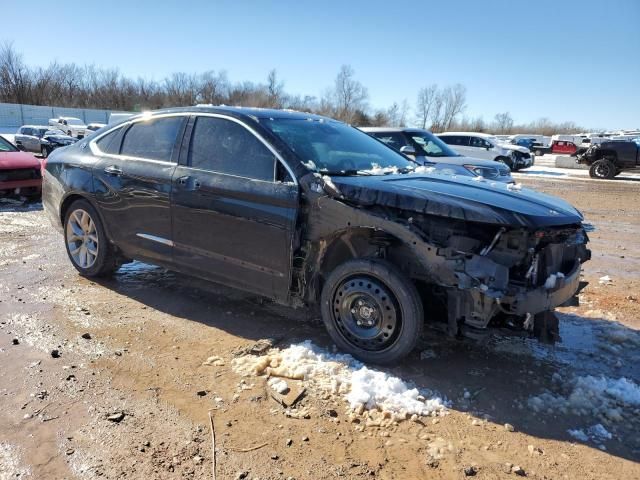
[331,173,582,228]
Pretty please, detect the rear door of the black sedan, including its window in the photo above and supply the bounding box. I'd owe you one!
[91,114,188,264]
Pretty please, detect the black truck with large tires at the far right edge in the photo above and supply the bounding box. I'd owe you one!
[575,139,640,179]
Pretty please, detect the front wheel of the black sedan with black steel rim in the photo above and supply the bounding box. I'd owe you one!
[321,258,424,365]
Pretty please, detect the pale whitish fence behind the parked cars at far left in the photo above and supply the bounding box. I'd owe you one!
[0,103,130,133]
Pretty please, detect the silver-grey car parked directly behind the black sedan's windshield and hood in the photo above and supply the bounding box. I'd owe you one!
[360,127,514,183]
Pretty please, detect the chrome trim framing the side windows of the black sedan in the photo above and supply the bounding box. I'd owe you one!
[89,111,298,186]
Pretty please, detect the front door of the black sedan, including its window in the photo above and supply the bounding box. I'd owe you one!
[171,115,298,299]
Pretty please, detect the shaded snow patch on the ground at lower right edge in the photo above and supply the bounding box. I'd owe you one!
[528,375,640,422]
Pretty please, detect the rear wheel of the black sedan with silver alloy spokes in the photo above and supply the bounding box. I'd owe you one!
[64,200,120,277]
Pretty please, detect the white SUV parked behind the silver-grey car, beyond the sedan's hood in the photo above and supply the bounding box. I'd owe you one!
[438,132,534,171]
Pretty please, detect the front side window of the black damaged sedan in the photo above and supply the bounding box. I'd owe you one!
[188,117,276,182]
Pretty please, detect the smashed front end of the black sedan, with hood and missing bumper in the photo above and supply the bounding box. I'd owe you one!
[293,175,590,341]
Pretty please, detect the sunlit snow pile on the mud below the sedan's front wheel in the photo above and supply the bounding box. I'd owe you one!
[233,341,449,421]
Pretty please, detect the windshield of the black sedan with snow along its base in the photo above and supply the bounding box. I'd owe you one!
[261,118,416,175]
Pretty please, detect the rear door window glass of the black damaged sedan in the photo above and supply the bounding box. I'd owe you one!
[120,117,185,162]
